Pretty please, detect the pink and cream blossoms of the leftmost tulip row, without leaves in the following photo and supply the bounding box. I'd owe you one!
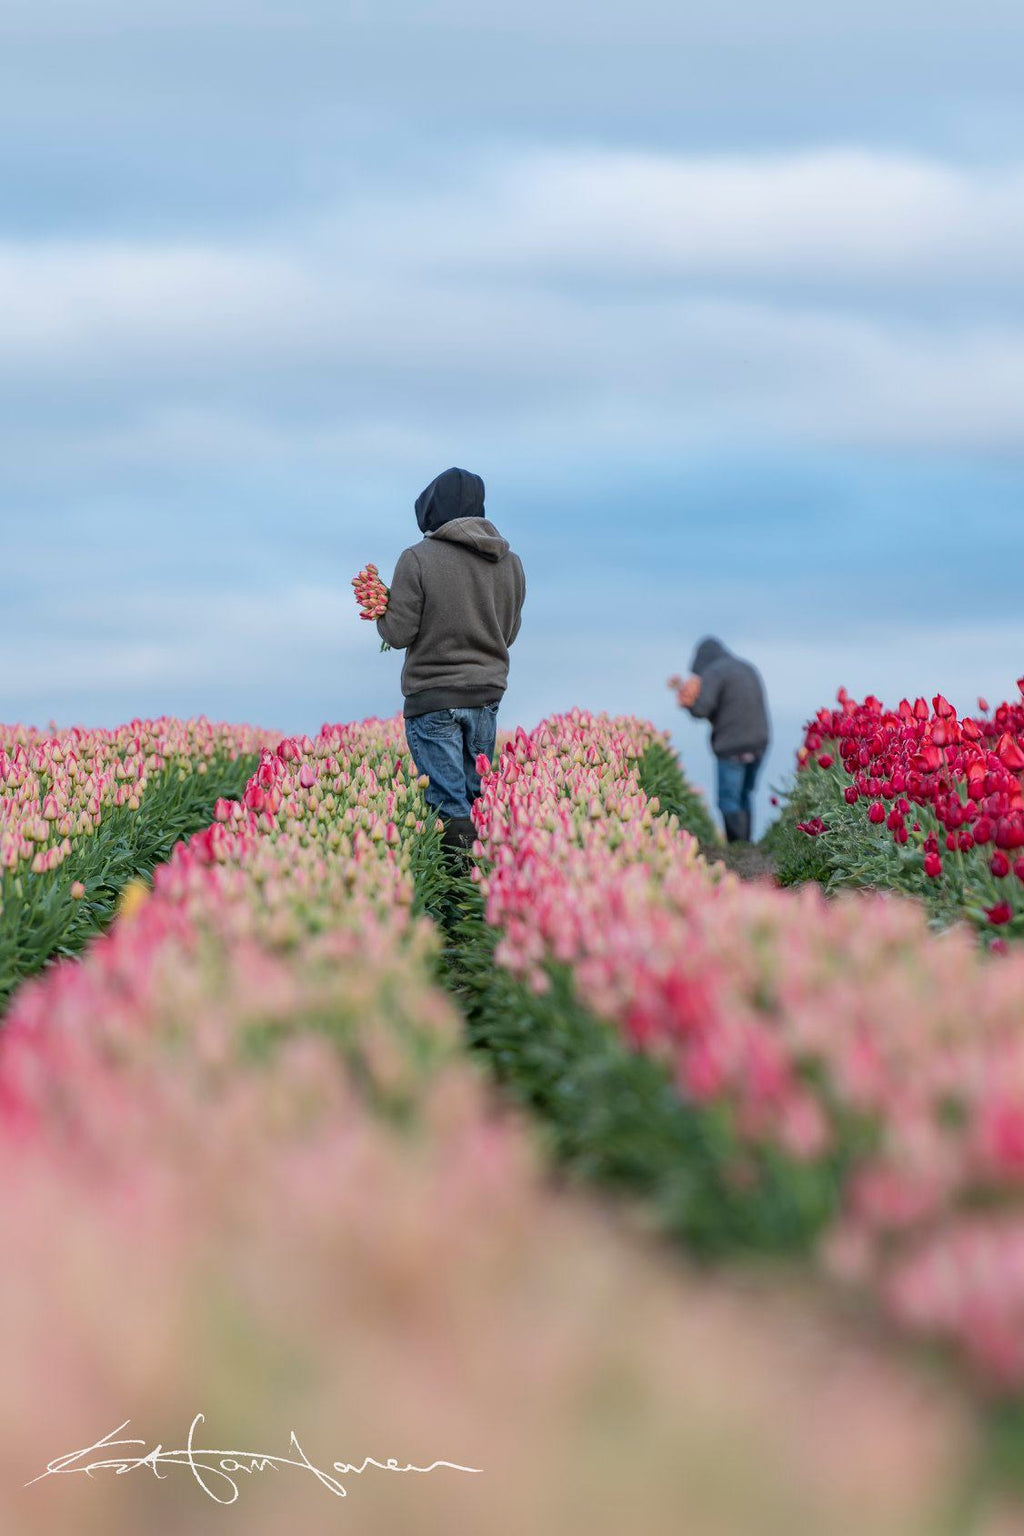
[0,717,278,874]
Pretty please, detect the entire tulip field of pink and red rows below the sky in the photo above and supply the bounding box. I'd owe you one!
[0,696,1024,1536]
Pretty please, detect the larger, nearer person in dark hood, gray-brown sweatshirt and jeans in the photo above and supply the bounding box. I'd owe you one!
[378,468,527,848]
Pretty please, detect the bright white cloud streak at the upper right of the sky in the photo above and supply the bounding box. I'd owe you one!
[373,149,1024,286]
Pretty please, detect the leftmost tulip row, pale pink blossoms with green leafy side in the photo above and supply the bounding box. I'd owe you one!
[0,717,278,1009]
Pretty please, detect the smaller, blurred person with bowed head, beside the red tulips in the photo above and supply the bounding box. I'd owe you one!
[671,636,771,843]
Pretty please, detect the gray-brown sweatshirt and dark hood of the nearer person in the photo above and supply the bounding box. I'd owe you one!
[378,470,527,719]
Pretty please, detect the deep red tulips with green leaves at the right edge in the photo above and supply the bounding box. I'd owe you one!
[785,679,1024,940]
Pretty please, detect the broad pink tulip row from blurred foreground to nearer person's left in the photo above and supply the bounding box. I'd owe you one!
[0,722,970,1536]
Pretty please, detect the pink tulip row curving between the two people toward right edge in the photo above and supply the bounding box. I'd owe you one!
[474,713,1024,1396]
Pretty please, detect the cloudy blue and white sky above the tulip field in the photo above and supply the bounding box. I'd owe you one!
[0,0,1024,823]
